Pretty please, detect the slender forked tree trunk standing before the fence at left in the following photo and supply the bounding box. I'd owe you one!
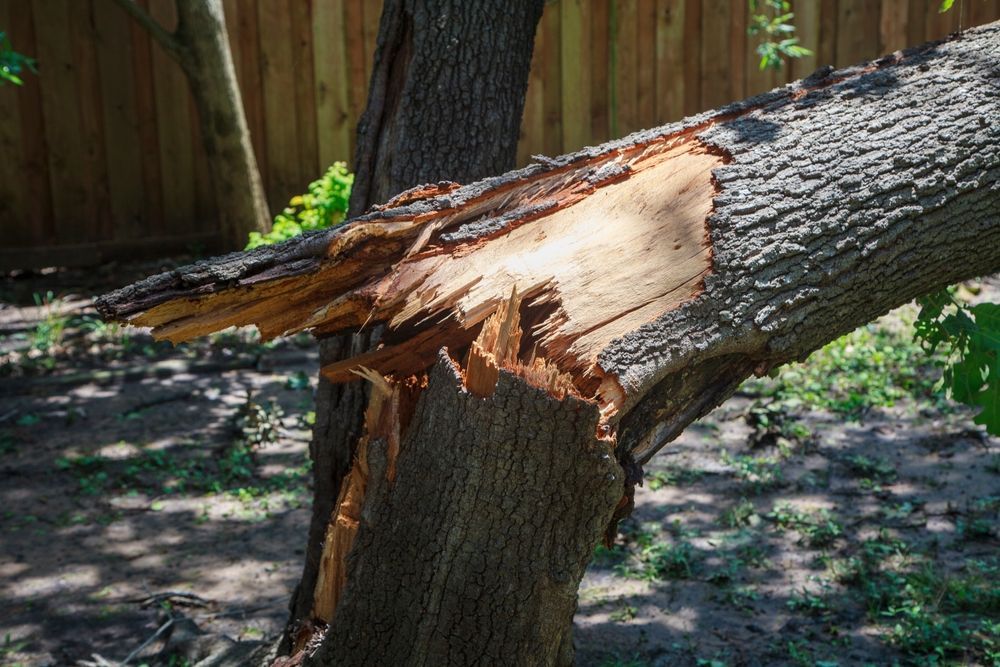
[116,0,271,249]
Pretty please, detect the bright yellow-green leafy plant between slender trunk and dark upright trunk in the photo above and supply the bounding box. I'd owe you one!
[246,162,354,250]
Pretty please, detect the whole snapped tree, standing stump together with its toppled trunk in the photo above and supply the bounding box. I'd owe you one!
[98,24,1000,664]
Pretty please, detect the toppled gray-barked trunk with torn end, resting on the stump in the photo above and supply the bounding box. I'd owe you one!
[97,24,1000,458]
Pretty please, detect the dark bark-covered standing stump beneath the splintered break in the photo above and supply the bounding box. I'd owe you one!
[305,353,623,665]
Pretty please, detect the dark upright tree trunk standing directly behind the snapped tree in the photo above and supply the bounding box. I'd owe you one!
[289,0,543,652]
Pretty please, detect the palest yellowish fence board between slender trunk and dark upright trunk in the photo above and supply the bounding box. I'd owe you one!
[312,0,354,170]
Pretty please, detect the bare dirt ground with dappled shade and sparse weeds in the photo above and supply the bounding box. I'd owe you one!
[0,264,1000,666]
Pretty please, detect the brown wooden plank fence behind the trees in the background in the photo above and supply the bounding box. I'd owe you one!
[0,0,1000,269]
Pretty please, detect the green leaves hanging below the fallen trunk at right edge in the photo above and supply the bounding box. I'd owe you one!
[915,288,1000,435]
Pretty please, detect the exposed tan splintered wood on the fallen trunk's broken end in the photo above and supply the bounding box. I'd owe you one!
[115,133,723,406]
